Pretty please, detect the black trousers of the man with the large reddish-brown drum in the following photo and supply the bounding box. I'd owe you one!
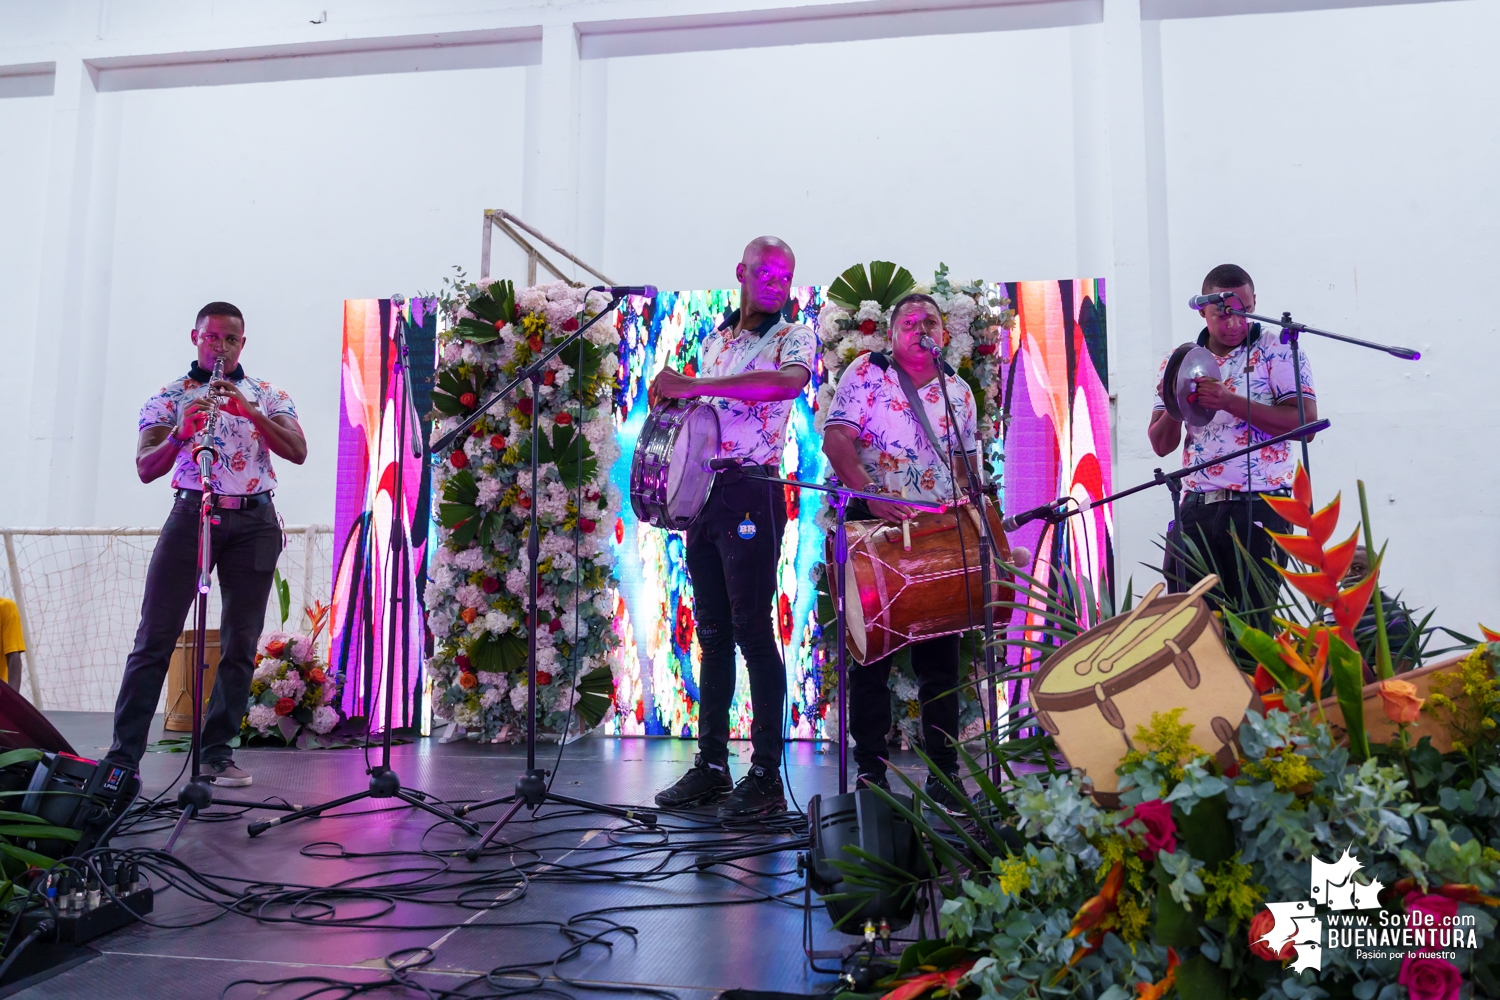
[849,636,962,775]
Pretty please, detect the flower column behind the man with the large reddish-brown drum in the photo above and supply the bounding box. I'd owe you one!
[815,261,1016,747]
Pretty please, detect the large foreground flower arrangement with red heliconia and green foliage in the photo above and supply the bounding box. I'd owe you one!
[840,475,1500,1000]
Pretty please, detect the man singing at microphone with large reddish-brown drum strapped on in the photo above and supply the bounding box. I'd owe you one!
[824,294,978,808]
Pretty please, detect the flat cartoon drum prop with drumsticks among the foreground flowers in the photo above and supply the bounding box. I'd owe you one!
[1031,576,1265,808]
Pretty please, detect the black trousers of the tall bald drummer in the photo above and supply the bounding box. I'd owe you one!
[687,472,786,771]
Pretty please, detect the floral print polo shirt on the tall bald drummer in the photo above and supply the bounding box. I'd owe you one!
[699,310,818,468]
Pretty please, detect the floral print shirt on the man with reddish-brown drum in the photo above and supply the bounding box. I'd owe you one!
[828,354,977,502]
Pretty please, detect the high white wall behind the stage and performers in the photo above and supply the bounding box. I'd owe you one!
[0,0,1500,628]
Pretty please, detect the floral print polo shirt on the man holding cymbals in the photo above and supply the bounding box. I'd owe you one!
[1152,324,1317,493]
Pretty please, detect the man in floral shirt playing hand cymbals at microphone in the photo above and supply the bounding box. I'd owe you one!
[1148,264,1317,628]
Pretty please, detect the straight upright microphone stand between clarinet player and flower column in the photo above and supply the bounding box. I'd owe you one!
[246,297,479,837]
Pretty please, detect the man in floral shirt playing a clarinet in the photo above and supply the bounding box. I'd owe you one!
[107,301,308,787]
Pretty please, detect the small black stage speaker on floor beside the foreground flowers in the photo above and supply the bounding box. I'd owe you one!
[807,789,921,934]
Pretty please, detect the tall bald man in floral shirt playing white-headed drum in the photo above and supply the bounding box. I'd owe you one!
[650,237,818,820]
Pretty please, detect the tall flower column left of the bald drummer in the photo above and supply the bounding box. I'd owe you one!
[426,274,621,742]
